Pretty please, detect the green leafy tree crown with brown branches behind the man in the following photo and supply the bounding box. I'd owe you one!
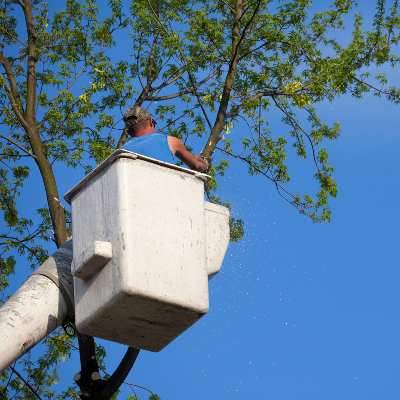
[0,0,400,399]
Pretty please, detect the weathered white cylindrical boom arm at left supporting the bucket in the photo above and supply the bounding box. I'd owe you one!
[0,241,73,372]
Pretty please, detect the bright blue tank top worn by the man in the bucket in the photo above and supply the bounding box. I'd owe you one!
[122,133,175,164]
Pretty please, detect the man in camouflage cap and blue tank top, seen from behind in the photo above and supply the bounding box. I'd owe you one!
[122,107,211,172]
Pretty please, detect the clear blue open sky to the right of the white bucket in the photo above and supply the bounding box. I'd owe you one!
[3,1,400,400]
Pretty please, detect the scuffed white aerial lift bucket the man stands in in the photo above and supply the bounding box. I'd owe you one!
[65,150,229,351]
